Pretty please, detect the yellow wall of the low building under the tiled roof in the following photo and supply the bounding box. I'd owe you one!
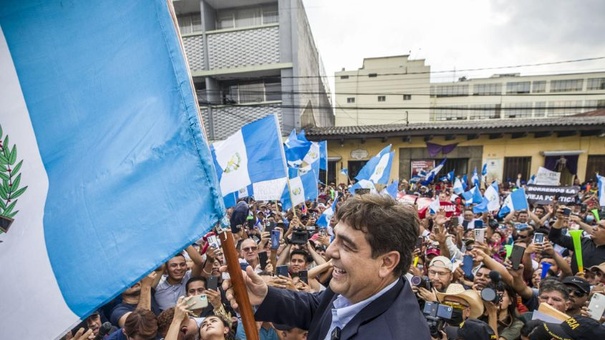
[328,134,605,182]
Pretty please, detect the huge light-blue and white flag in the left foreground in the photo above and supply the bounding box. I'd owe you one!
[0,0,224,339]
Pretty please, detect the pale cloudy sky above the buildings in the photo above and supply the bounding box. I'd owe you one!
[303,0,605,86]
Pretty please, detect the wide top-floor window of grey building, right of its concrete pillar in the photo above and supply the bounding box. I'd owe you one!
[216,5,279,29]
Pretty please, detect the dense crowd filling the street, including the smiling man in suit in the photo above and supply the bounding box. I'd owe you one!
[65,180,605,340]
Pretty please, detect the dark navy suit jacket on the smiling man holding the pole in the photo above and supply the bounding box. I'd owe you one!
[255,278,431,340]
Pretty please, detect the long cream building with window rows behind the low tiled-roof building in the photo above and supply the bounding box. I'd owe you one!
[335,56,605,126]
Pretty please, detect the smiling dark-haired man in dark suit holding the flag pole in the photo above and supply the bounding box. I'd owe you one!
[228,194,430,340]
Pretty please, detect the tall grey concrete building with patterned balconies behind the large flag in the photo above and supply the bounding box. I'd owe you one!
[173,0,334,140]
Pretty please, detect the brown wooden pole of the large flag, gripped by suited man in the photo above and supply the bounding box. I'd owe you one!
[219,229,259,340]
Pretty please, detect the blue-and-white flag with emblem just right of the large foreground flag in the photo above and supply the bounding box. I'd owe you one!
[212,115,288,207]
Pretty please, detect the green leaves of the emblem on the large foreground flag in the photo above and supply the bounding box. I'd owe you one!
[0,125,27,218]
